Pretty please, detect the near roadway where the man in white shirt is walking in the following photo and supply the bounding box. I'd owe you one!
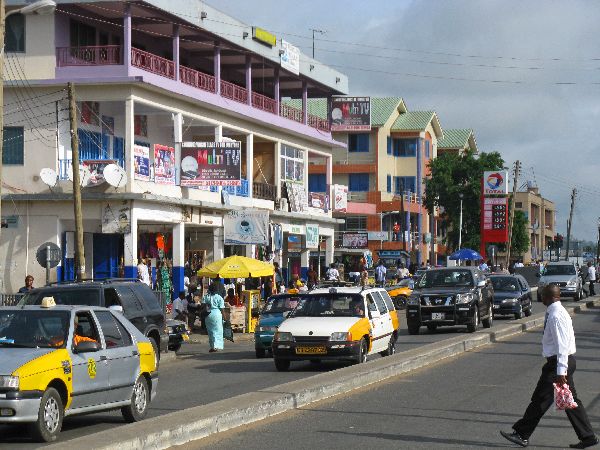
[185,308,600,450]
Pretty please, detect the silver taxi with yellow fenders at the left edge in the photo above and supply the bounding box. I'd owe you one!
[0,297,158,442]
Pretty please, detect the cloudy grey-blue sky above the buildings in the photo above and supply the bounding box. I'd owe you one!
[207,0,600,241]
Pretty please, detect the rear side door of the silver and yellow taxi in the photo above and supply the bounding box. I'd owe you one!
[94,311,140,403]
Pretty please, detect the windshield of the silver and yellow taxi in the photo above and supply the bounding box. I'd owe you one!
[0,309,71,348]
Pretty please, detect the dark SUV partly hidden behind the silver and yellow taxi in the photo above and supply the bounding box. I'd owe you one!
[19,279,169,366]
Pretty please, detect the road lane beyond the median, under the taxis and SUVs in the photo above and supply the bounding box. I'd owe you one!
[0,296,588,449]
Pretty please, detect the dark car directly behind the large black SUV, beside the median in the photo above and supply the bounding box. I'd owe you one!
[489,274,533,319]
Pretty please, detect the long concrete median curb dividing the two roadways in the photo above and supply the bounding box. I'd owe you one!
[47,299,600,450]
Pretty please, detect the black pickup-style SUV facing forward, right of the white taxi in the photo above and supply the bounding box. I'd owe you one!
[406,267,494,334]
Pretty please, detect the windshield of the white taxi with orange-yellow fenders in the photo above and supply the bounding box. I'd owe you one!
[292,294,365,317]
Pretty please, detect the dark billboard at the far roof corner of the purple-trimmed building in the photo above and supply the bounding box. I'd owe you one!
[329,97,371,131]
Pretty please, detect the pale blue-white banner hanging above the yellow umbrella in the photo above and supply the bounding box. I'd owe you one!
[223,210,269,245]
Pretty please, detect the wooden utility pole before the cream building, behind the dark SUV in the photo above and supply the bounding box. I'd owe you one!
[67,83,85,281]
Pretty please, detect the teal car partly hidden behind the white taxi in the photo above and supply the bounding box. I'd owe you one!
[254,293,298,358]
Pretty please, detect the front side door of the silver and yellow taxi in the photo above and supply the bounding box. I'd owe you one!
[68,311,109,409]
